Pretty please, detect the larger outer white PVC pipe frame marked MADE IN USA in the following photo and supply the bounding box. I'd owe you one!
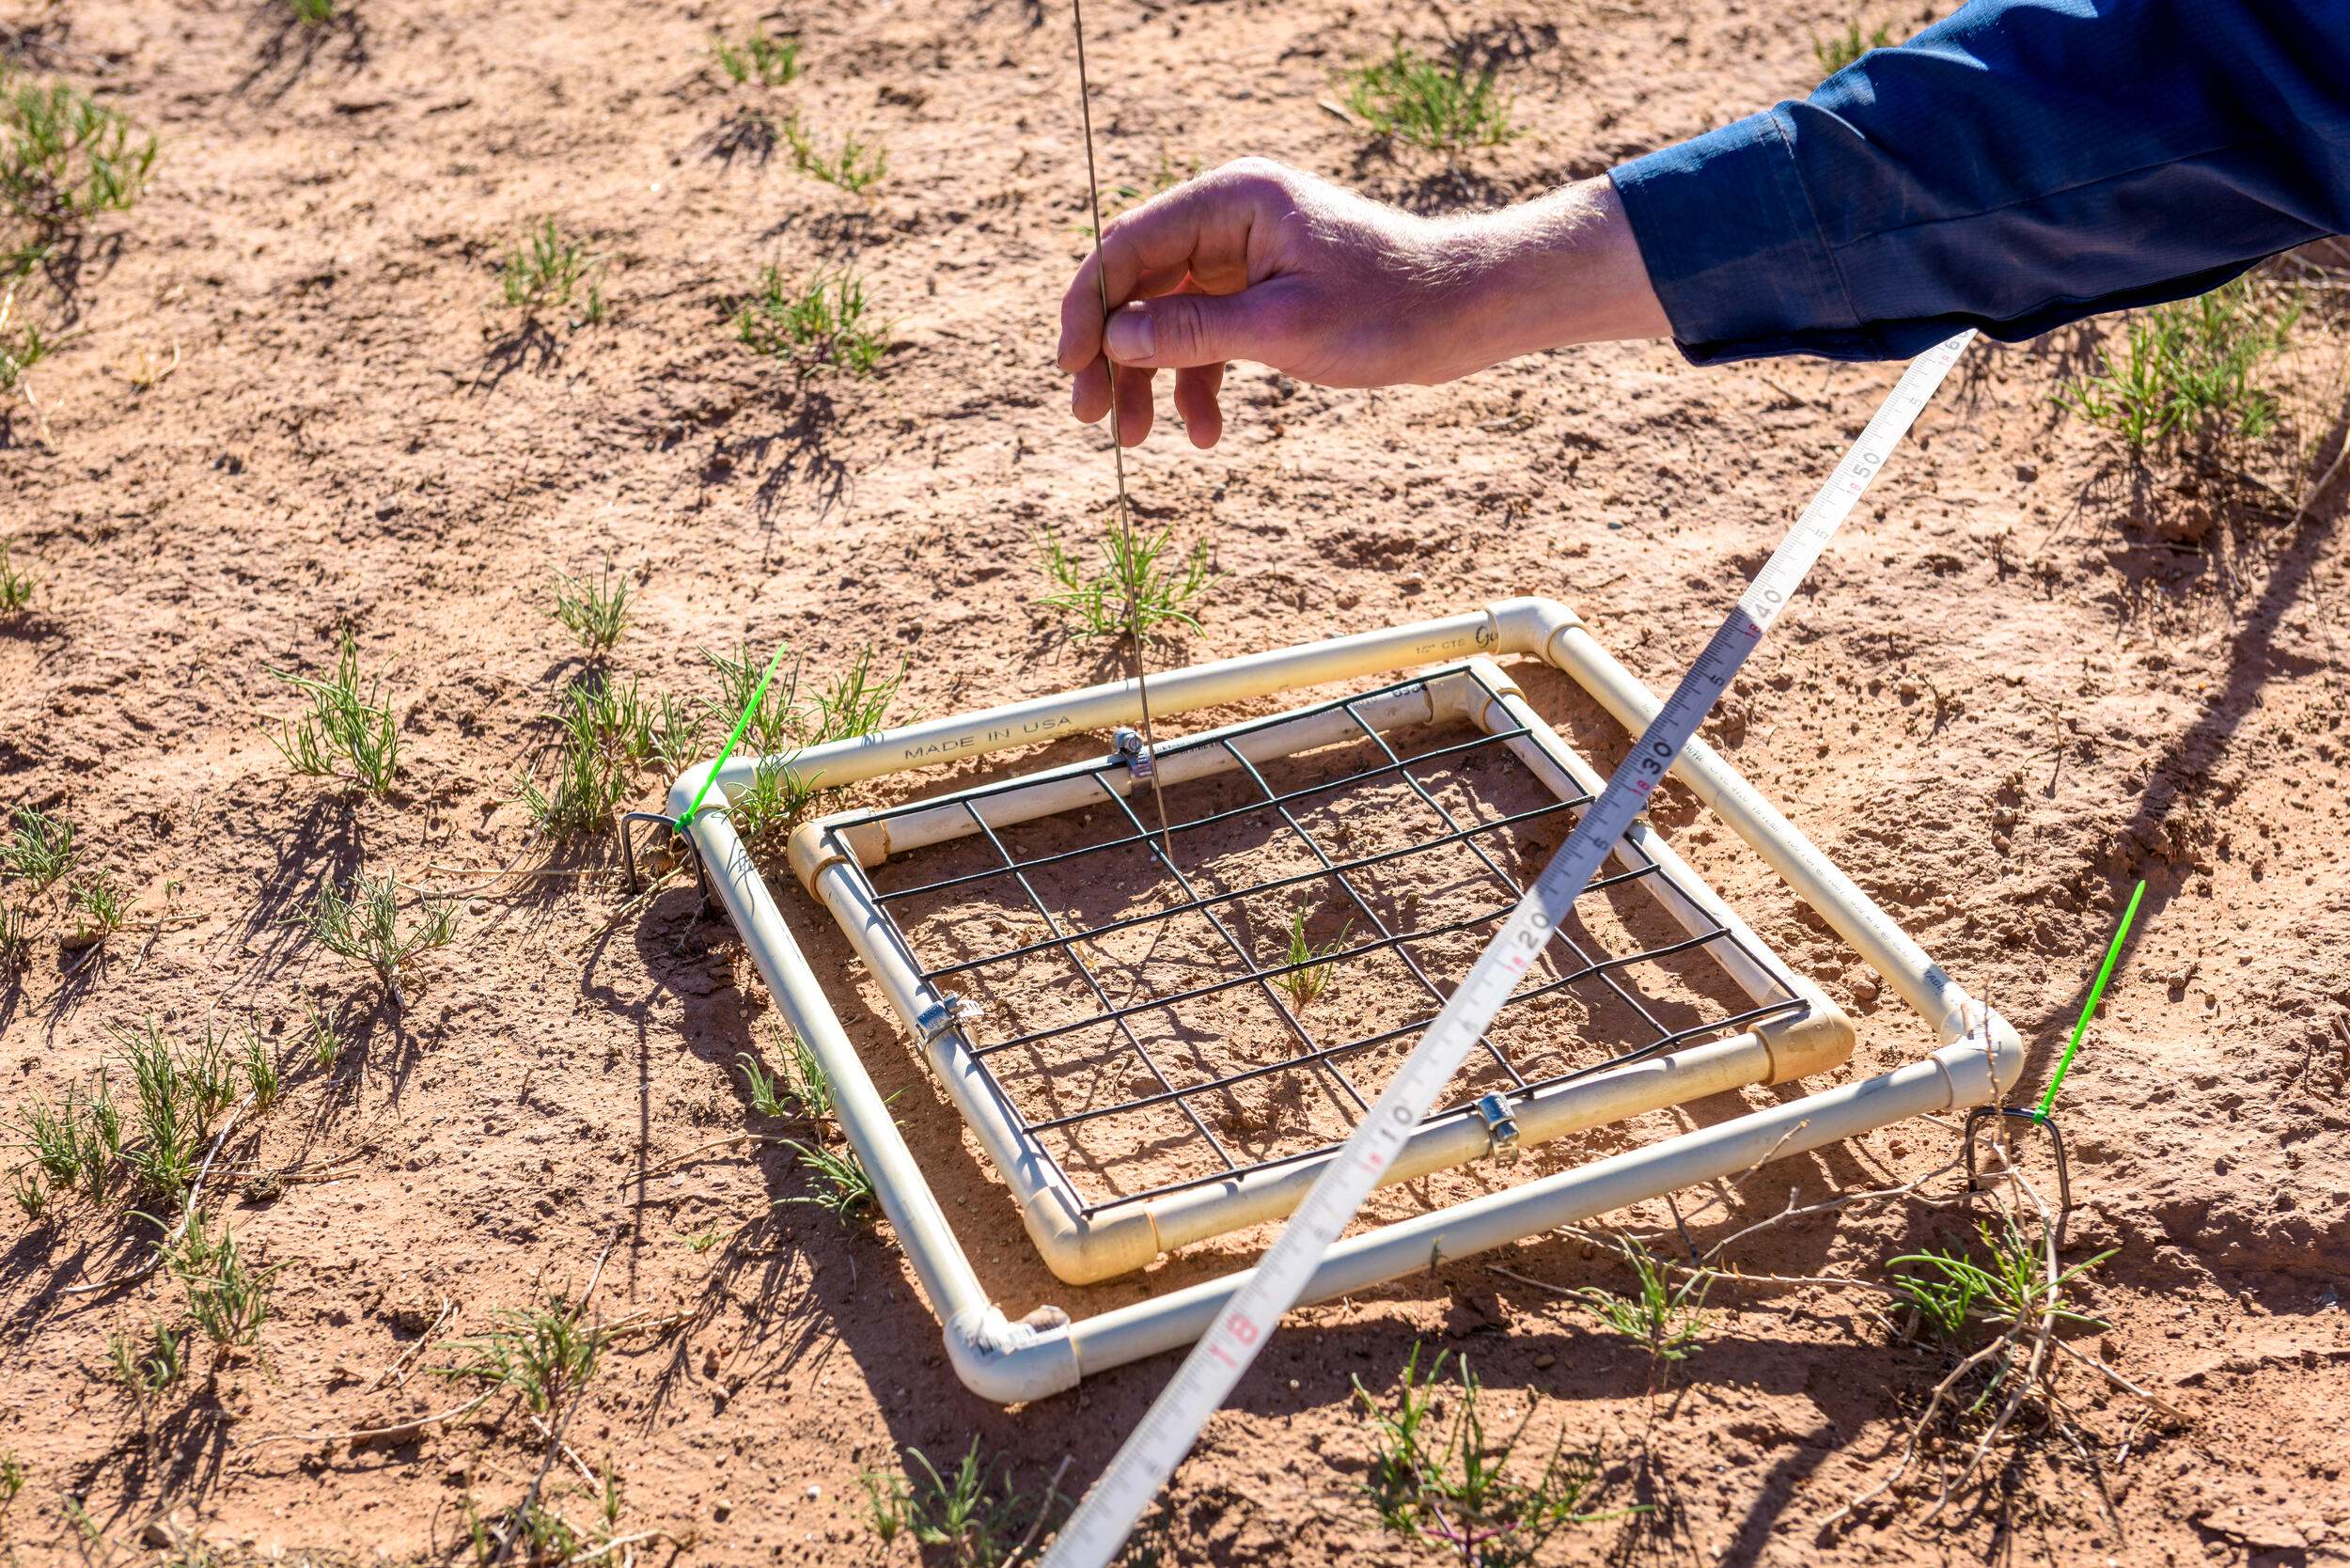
[670,600,2024,1403]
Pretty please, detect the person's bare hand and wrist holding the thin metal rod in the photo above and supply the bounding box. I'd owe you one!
[1058,158,1667,447]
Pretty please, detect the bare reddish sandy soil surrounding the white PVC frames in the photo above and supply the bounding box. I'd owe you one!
[0,0,2350,1565]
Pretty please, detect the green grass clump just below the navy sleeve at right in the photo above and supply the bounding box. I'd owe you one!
[2057,277,2301,451]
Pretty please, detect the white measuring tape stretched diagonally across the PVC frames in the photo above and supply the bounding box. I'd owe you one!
[1043,332,1974,1568]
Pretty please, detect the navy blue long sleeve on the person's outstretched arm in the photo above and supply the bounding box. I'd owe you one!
[1612,0,2350,365]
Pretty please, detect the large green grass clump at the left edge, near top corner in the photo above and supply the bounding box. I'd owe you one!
[0,59,155,275]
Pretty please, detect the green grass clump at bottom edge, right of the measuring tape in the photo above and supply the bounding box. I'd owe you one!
[1354,1344,1612,1565]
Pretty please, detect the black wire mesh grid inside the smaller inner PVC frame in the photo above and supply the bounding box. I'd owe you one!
[832,666,1805,1215]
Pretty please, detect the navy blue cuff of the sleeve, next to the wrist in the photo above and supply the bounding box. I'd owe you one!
[1610,111,1888,365]
